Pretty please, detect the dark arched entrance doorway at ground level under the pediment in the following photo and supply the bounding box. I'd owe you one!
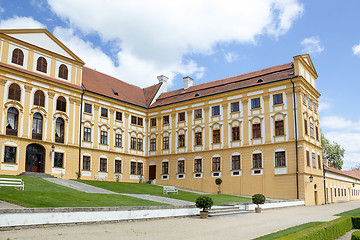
[25,143,45,173]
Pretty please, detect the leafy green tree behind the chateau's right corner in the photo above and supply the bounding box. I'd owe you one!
[321,133,345,170]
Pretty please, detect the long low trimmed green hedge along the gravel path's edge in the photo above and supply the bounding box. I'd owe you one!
[279,217,352,240]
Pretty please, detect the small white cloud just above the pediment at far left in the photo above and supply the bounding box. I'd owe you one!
[0,16,46,29]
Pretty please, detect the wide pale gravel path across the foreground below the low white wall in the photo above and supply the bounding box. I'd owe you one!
[0,201,360,240]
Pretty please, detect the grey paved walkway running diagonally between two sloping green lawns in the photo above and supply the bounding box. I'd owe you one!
[44,178,194,206]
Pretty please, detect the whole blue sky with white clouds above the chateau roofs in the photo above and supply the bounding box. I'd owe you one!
[0,0,360,169]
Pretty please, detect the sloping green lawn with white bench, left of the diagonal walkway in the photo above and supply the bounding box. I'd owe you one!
[0,175,165,208]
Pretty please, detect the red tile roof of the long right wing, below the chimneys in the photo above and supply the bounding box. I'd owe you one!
[150,63,294,107]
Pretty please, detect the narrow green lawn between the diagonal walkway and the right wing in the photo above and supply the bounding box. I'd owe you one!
[78,180,251,205]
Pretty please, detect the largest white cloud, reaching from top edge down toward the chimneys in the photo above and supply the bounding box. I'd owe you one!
[48,0,303,86]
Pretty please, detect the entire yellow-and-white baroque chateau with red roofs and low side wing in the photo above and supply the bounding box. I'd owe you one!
[0,29,360,205]
